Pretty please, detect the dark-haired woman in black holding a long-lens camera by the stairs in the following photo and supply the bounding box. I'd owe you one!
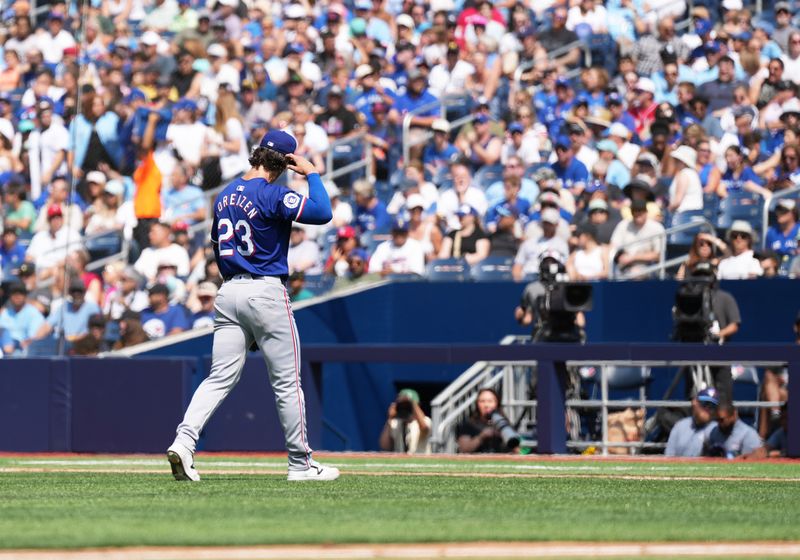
[456,388,520,453]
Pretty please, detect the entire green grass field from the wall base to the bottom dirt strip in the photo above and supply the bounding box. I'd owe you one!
[0,454,800,548]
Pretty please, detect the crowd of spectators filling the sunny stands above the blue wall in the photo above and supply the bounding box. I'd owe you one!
[0,0,800,354]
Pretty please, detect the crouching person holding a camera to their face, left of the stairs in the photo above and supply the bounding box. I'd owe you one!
[379,389,431,455]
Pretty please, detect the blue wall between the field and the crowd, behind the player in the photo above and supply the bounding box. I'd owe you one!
[0,279,800,452]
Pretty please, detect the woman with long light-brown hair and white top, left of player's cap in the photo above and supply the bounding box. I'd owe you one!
[209,91,250,182]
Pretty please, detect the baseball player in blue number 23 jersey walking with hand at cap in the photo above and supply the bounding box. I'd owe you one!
[167,131,339,481]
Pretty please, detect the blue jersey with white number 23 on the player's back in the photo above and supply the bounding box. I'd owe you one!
[211,178,307,278]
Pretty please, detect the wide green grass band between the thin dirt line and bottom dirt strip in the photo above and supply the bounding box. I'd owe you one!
[0,473,800,548]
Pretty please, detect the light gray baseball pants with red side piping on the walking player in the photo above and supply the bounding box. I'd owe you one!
[175,274,311,470]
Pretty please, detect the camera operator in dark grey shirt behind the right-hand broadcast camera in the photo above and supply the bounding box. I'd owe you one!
[673,261,742,402]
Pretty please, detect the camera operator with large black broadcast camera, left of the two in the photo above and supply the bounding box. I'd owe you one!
[514,251,586,342]
